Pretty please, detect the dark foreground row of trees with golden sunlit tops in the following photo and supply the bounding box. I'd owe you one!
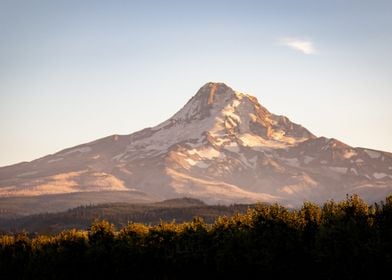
[0,195,392,279]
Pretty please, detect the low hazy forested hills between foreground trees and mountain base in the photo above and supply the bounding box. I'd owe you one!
[0,198,254,235]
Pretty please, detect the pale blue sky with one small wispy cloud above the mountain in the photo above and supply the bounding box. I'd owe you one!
[0,0,392,166]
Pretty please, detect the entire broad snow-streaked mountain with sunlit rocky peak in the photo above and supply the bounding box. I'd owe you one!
[0,83,392,211]
